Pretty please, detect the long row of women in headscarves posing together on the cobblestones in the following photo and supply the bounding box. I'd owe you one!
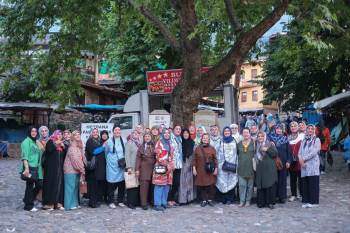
[21,122,320,211]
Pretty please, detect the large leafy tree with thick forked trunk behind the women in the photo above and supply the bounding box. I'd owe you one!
[0,0,344,125]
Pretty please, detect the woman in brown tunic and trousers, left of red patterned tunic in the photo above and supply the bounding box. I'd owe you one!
[135,133,156,210]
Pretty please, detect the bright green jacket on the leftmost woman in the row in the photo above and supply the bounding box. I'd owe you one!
[20,137,43,179]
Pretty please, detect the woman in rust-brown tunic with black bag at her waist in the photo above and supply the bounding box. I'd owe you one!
[192,133,218,207]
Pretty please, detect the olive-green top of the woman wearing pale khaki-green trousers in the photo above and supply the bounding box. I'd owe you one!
[237,140,255,178]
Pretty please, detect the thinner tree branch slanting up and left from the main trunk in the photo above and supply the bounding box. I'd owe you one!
[128,0,181,51]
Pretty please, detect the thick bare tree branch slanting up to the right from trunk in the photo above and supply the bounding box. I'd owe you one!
[201,0,291,94]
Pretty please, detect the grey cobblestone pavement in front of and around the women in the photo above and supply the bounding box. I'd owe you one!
[0,152,350,233]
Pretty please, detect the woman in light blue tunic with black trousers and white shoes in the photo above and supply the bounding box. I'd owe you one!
[105,126,126,209]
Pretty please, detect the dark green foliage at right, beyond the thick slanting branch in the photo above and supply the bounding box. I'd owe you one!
[260,1,350,111]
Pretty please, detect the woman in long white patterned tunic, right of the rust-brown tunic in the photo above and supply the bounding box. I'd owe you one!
[216,127,238,205]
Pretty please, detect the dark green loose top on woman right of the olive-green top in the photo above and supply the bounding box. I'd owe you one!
[255,145,278,189]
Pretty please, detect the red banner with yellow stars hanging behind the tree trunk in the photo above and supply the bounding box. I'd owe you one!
[146,67,209,95]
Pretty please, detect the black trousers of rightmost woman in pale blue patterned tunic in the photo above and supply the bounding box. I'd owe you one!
[301,176,320,204]
